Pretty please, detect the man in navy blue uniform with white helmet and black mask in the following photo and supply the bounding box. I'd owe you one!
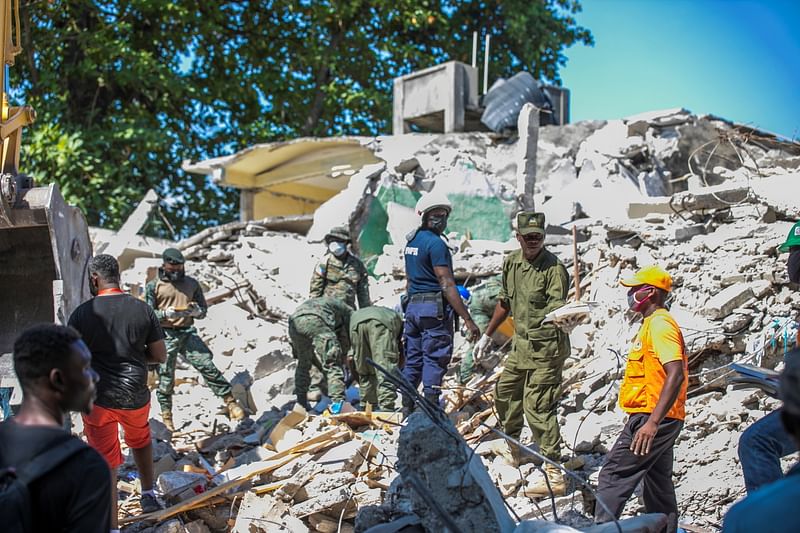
[403,193,480,415]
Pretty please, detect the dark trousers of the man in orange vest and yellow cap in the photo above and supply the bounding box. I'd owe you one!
[594,413,683,531]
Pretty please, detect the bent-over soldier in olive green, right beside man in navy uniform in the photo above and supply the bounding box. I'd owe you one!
[350,306,403,411]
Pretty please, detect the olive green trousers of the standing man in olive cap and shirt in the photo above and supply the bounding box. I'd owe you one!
[495,361,563,461]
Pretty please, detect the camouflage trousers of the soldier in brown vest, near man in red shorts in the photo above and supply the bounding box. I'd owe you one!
[156,327,231,411]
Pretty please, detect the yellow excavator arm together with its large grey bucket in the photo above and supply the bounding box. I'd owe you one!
[0,0,92,378]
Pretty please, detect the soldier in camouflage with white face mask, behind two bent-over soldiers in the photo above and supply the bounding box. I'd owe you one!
[309,226,372,309]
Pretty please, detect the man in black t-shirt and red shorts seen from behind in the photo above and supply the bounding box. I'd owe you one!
[69,254,167,529]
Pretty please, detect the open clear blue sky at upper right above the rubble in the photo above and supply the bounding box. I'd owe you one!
[561,0,800,139]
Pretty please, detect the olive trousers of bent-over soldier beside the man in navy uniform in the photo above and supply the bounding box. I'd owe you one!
[350,320,400,411]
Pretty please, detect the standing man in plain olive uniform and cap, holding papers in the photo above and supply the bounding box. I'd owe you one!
[475,212,570,497]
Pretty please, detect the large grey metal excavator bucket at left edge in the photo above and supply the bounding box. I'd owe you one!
[0,181,92,356]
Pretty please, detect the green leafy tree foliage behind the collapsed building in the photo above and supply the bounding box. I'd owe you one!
[11,0,592,235]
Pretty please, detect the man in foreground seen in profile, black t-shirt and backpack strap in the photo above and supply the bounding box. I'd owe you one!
[0,324,111,533]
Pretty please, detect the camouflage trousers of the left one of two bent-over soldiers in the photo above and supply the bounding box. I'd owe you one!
[289,315,345,402]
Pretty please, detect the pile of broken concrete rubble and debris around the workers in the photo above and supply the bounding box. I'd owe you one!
[114,109,800,531]
